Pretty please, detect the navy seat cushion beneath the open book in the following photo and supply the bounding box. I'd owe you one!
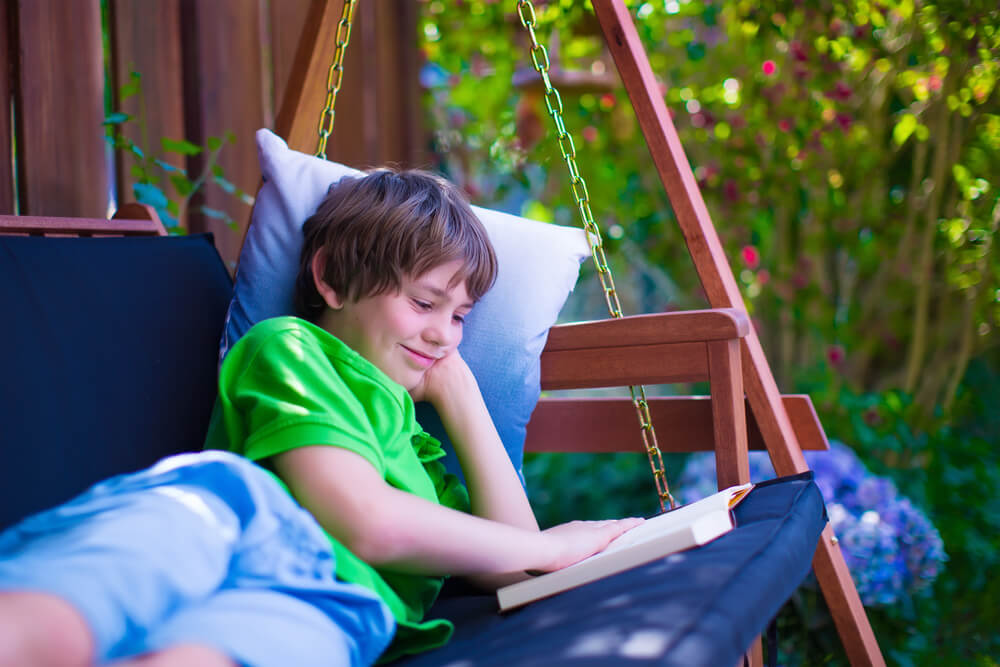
[392,473,826,667]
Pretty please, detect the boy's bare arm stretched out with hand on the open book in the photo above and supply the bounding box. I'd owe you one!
[272,446,638,585]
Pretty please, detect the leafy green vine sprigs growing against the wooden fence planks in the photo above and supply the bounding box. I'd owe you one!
[104,72,253,234]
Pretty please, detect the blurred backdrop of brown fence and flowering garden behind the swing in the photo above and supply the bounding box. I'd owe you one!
[0,0,1000,665]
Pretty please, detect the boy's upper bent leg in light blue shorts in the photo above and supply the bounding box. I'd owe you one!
[0,456,240,665]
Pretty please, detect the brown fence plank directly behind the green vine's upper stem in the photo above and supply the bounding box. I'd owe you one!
[109,0,187,225]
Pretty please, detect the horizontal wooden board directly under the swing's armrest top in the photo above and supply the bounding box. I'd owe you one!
[542,343,708,389]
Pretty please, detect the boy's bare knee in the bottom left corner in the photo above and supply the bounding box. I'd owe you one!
[0,592,94,667]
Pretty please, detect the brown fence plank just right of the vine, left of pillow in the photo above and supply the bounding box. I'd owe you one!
[182,0,263,267]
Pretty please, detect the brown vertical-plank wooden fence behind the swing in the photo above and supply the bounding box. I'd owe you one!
[0,0,426,262]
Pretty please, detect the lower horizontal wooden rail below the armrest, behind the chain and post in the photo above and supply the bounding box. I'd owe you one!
[524,394,830,453]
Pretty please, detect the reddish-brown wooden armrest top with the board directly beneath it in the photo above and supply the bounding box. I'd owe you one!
[541,308,750,389]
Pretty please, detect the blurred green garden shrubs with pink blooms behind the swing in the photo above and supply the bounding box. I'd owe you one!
[421,0,1000,665]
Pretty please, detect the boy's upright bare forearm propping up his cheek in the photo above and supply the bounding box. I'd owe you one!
[415,350,538,531]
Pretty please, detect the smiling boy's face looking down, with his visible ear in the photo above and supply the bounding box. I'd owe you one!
[320,260,473,391]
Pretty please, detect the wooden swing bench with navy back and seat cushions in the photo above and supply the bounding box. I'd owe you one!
[0,207,812,665]
